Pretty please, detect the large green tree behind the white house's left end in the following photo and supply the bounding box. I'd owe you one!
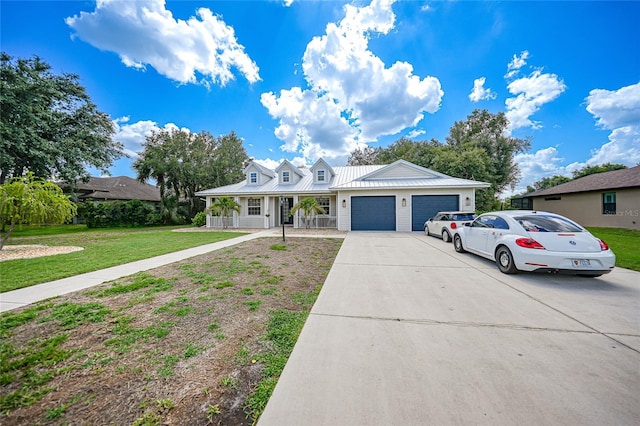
[133,129,249,216]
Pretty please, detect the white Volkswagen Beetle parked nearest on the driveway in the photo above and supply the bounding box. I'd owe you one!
[453,210,616,277]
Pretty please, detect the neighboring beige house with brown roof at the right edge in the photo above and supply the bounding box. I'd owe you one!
[511,166,640,229]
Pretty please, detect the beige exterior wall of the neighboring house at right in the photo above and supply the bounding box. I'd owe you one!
[533,188,640,229]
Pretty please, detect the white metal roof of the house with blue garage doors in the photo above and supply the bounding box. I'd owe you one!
[196,160,490,196]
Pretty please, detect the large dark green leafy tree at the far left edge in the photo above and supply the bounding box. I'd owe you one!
[0,52,124,183]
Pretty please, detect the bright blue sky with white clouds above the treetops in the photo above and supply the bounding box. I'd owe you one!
[0,0,640,192]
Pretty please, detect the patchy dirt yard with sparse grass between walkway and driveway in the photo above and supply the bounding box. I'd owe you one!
[0,237,342,425]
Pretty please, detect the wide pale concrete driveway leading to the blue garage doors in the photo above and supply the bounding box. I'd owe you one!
[259,232,640,426]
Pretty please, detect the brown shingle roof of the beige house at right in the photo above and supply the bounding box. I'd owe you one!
[522,166,640,198]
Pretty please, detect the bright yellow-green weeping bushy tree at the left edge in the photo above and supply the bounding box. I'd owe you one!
[0,173,76,250]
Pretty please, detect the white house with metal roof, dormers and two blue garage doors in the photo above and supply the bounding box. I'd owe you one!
[196,159,489,231]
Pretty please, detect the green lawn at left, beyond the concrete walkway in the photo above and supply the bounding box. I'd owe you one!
[0,225,244,292]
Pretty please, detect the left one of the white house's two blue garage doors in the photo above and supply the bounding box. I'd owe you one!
[351,195,396,231]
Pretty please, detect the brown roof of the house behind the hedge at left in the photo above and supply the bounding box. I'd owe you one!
[58,176,161,202]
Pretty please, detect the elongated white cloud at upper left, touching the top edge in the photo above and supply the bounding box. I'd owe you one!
[65,0,260,86]
